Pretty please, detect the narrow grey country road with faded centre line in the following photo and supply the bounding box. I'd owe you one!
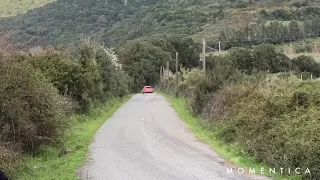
[80,94,267,180]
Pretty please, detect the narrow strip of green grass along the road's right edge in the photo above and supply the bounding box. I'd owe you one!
[160,93,301,180]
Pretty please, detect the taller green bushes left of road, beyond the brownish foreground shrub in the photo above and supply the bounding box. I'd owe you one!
[24,39,130,112]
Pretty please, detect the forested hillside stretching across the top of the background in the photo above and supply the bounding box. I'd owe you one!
[0,0,320,48]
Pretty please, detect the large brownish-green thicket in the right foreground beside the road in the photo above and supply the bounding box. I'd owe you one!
[204,75,320,178]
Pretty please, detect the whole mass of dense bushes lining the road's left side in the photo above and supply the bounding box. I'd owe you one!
[0,40,131,174]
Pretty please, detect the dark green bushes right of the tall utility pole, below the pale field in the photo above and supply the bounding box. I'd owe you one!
[207,44,320,77]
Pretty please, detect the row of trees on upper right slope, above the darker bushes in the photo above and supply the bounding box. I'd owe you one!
[218,18,320,49]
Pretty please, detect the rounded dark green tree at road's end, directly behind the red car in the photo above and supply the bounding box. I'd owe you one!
[116,40,173,92]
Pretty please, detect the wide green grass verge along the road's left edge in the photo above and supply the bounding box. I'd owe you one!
[14,95,132,180]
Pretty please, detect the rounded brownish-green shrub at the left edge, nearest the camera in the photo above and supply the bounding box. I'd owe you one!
[0,56,68,152]
